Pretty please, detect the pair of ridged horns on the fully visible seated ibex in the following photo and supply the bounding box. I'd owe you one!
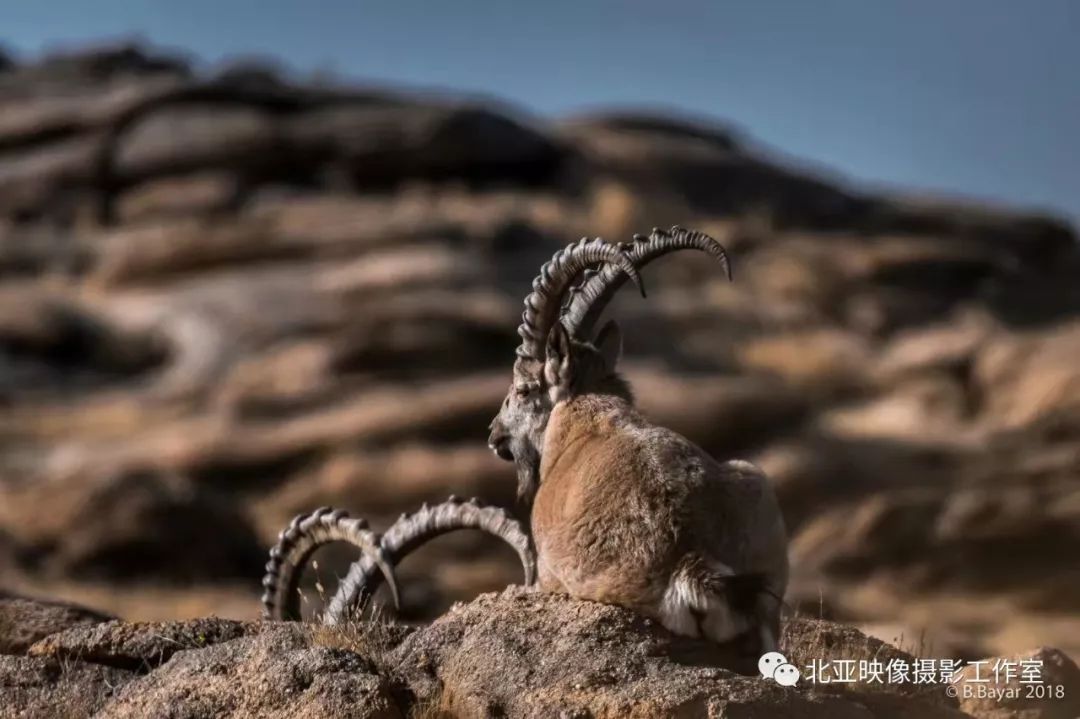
[516,226,731,360]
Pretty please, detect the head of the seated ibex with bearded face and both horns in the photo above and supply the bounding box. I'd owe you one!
[488,227,731,505]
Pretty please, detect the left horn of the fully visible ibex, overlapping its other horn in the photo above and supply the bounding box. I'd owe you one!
[517,238,645,360]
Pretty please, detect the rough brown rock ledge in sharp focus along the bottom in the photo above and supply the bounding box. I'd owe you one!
[6,587,1080,719]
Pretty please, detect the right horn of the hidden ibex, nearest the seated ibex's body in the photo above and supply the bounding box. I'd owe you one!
[323,497,537,624]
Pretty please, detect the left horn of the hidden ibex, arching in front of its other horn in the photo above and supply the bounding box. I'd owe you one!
[262,506,400,621]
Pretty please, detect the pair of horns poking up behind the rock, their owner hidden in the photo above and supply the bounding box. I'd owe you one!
[262,497,536,624]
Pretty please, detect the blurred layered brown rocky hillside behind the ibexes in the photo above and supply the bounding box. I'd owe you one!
[0,48,1080,656]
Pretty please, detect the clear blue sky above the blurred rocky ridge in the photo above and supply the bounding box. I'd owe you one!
[0,0,1080,220]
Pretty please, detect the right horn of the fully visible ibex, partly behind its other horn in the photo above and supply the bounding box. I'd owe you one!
[563,225,731,341]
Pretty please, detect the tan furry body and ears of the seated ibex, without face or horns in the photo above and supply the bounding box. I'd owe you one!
[532,325,787,660]
